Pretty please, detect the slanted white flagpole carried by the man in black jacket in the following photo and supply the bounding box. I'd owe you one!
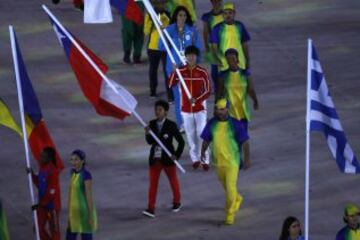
[42,5,185,173]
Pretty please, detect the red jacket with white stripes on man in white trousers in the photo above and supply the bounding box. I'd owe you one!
[169,65,210,113]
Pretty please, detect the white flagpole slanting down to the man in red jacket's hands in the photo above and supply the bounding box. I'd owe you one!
[142,0,192,100]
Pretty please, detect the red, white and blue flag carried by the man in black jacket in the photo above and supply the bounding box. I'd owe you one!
[47,12,137,119]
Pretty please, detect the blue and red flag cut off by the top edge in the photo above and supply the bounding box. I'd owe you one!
[110,0,144,25]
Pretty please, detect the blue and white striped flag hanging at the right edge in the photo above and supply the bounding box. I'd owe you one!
[308,40,360,173]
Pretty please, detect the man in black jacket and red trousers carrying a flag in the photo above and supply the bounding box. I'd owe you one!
[143,100,185,218]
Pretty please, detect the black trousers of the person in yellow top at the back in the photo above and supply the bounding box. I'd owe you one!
[148,49,173,100]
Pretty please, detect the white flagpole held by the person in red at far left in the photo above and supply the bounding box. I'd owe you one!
[9,25,40,240]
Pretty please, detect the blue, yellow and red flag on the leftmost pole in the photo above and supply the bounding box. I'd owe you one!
[14,32,64,170]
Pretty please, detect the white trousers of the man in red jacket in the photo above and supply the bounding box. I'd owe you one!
[181,110,209,164]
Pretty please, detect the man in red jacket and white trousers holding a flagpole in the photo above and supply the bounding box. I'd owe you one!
[169,46,211,171]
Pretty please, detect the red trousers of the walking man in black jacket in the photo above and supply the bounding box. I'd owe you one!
[148,161,181,210]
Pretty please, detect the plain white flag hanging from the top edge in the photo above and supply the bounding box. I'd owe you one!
[84,0,113,23]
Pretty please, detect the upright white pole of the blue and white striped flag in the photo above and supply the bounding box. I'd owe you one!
[305,39,312,240]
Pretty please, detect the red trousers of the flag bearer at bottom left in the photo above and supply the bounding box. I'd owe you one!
[36,207,60,240]
